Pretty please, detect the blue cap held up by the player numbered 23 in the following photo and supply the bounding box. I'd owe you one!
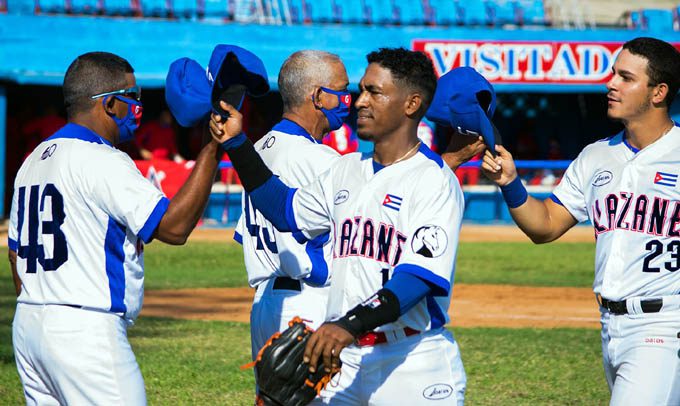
[425,66,501,154]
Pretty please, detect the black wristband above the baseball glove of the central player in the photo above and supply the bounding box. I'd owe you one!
[331,289,399,338]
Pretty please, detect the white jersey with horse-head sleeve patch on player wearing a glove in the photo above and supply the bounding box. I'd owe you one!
[288,145,464,331]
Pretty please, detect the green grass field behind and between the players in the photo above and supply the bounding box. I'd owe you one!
[0,242,608,405]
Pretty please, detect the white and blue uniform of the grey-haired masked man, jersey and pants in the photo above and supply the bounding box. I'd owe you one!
[235,119,339,359]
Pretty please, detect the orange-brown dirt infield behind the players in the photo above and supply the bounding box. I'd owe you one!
[149,225,599,328]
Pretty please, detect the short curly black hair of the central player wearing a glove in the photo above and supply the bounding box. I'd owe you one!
[366,48,437,115]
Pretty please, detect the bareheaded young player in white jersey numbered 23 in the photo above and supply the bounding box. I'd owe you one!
[482,38,680,405]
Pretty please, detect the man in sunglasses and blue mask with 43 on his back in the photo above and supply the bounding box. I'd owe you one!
[9,52,236,405]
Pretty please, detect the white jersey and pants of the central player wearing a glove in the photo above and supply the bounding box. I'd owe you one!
[287,145,466,405]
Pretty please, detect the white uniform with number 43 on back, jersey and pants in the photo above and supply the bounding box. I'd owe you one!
[9,124,169,404]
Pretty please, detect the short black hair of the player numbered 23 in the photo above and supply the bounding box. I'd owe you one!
[623,37,680,107]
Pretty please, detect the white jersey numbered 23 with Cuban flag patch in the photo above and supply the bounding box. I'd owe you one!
[553,127,680,301]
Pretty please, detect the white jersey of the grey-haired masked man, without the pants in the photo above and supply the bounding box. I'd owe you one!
[235,119,340,288]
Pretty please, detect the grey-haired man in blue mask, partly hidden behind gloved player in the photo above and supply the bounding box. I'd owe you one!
[235,50,351,359]
